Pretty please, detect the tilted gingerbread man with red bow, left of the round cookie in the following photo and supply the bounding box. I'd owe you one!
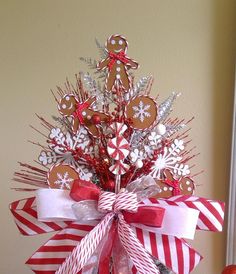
[58,94,108,136]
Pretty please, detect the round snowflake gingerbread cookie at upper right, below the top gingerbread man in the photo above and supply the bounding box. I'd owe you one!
[125,95,157,130]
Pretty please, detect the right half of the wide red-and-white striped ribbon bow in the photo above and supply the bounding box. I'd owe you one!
[130,195,224,274]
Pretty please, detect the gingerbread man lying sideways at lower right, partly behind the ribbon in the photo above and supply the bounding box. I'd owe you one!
[155,169,195,198]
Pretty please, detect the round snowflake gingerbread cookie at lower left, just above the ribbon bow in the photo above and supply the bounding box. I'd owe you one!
[47,164,79,189]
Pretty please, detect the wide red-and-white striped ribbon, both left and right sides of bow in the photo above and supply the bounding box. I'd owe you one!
[10,195,224,274]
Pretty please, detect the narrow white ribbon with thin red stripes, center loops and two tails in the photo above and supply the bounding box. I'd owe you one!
[56,192,159,274]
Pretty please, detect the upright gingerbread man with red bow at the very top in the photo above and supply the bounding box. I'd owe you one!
[97,35,138,91]
